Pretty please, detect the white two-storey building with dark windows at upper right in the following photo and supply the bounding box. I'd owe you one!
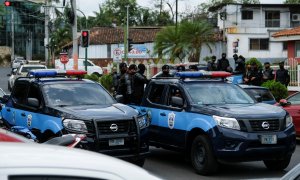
[214,4,300,62]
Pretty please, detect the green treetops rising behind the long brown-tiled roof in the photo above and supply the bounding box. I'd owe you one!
[78,0,173,29]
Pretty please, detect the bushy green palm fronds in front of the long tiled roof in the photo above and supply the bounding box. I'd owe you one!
[154,21,214,62]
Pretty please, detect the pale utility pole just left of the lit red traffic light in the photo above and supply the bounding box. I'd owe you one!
[71,0,78,70]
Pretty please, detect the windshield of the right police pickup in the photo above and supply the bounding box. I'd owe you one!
[186,83,254,105]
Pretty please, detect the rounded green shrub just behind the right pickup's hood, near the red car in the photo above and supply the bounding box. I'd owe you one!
[262,80,288,101]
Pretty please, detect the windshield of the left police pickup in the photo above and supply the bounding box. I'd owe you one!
[43,82,115,106]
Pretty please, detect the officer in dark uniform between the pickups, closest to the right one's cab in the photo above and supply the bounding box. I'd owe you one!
[133,64,148,104]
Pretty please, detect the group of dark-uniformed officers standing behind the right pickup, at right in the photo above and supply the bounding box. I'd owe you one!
[207,53,290,87]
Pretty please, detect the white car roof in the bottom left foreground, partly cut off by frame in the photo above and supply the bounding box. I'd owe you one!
[0,142,160,180]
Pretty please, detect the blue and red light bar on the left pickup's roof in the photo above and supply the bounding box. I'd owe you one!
[29,69,87,78]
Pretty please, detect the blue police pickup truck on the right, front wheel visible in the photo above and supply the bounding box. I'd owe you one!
[135,71,296,175]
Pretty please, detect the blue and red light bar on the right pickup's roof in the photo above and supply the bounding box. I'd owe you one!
[175,71,231,78]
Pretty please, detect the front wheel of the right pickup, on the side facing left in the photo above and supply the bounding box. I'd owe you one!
[191,135,219,175]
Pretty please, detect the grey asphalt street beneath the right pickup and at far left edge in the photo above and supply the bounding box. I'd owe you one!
[0,67,300,180]
